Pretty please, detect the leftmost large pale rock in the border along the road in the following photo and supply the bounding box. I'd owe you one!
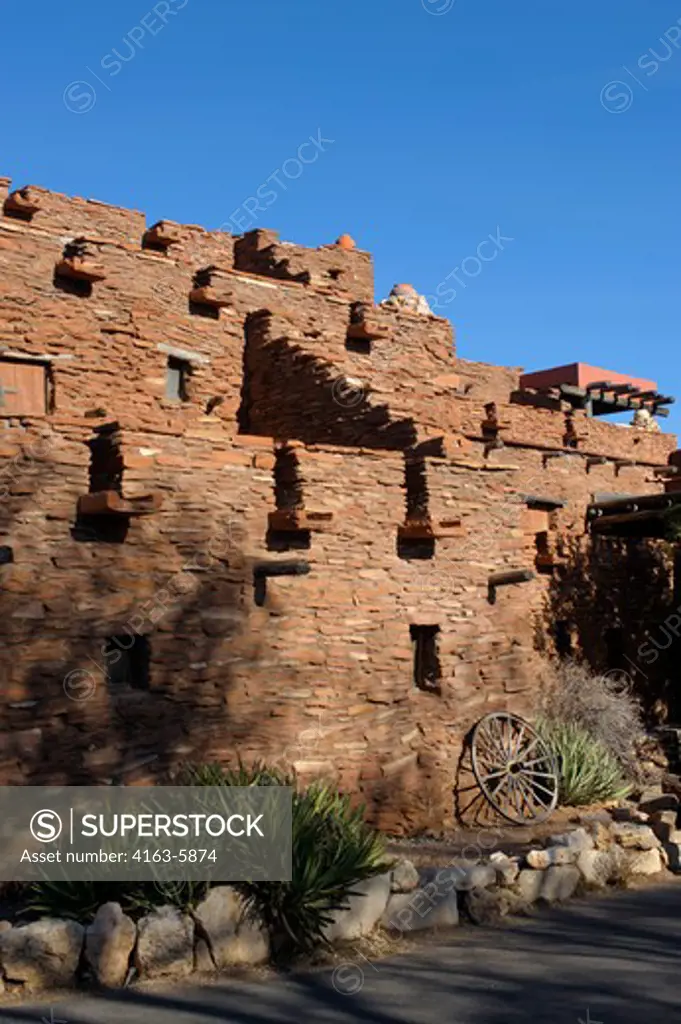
[0,918,84,990]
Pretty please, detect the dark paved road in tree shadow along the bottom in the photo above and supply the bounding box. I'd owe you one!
[5,886,681,1024]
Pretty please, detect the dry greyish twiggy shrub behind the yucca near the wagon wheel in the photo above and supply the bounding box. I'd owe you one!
[542,660,645,778]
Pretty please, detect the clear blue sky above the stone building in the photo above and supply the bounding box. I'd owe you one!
[0,0,681,429]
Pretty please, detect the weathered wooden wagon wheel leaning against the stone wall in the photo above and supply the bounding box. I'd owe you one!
[471,712,558,825]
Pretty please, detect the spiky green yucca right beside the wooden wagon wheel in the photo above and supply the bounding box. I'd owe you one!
[537,719,631,807]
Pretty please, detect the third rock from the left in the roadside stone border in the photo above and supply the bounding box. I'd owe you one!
[135,906,194,978]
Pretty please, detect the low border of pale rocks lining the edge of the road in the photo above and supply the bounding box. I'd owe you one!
[0,795,681,994]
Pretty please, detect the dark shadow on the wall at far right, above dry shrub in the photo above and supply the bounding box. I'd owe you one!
[544,537,681,725]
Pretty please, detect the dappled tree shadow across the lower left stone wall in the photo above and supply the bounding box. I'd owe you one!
[0,444,270,784]
